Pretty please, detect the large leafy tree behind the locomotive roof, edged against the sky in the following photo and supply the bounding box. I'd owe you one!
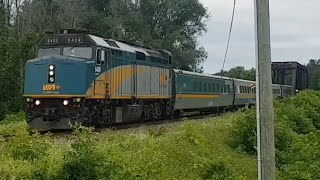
[85,0,208,71]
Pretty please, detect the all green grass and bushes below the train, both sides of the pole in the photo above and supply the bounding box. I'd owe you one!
[0,91,320,180]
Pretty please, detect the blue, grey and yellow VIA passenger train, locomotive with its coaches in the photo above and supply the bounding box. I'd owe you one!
[24,30,292,130]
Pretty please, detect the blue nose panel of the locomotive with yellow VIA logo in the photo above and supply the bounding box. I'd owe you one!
[24,55,88,97]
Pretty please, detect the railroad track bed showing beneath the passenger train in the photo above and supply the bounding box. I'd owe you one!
[0,109,230,141]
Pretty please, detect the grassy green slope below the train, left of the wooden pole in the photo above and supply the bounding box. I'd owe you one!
[0,115,256,179]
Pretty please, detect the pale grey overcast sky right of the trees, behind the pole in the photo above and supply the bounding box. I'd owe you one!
[199,0,320,73]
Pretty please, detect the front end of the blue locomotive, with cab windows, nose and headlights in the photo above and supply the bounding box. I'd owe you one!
[24,31,110,129]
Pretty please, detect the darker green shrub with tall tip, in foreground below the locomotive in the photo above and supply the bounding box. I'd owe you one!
[62,126,131,180]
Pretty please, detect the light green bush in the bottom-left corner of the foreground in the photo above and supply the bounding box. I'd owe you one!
[0,130,63,179]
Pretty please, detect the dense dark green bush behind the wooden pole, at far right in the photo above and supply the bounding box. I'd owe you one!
[231,91,320,179]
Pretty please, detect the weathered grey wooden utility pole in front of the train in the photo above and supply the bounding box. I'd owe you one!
[254,0,275,180]
